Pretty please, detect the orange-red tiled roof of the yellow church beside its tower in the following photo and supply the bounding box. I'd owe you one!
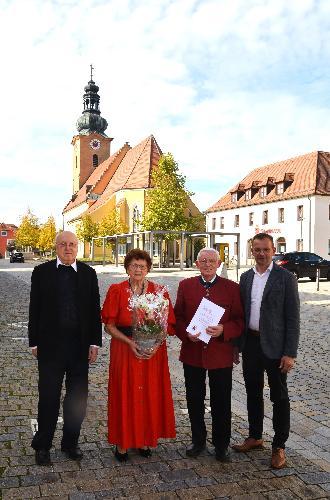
[87,135,162,213]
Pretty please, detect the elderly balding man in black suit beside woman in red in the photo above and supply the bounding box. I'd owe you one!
[28,231,102,465]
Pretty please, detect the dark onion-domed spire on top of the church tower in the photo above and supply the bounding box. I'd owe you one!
[77,65,108,137]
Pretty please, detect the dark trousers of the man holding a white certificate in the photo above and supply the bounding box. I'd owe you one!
[183,363,232,450]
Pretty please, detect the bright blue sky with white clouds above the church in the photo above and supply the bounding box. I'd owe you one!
[0,0,330,227]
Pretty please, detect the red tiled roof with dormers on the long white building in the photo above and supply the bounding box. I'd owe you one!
[206,151,330,212]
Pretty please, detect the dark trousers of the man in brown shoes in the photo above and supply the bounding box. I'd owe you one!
[243,335,290,448]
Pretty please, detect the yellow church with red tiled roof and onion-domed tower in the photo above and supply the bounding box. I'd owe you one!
[63,73,200,256]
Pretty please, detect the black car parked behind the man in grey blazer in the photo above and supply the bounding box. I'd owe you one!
[273,252,330,281]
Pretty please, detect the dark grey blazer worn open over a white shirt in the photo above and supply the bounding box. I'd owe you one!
[240,264,300,359]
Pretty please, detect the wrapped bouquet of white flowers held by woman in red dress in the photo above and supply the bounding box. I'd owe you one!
[129,288,169,354]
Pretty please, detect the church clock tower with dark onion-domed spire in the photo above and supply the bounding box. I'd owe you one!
[71,65,112,194]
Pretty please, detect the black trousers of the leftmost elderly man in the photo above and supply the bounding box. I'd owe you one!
[31,348,88,450]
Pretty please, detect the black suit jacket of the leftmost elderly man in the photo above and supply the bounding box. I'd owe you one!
[28,260,102,359]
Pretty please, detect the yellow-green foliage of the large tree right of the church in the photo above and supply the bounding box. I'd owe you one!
[141,153,202,239]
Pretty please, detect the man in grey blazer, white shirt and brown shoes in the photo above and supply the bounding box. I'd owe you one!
[233,233,300,469]
